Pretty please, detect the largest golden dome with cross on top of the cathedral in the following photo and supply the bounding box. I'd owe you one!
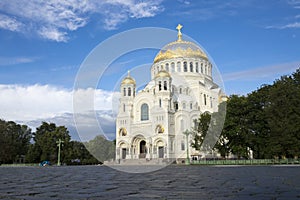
[154,24,208,63]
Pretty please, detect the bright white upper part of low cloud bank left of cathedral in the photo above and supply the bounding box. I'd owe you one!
[0,85,113,121]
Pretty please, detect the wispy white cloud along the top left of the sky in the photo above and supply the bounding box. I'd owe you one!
[0,0,163,42]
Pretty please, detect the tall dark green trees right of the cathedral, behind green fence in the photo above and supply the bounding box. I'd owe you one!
[191,68,300,159]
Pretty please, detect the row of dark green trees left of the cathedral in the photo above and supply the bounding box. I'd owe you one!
[0,120,114,165]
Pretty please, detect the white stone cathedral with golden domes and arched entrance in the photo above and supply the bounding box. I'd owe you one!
[116,24,224,164]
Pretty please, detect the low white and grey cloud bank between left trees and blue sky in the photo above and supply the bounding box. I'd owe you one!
[0,85,119,141]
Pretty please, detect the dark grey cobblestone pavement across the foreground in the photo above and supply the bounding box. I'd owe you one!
[0,165,300,199]
